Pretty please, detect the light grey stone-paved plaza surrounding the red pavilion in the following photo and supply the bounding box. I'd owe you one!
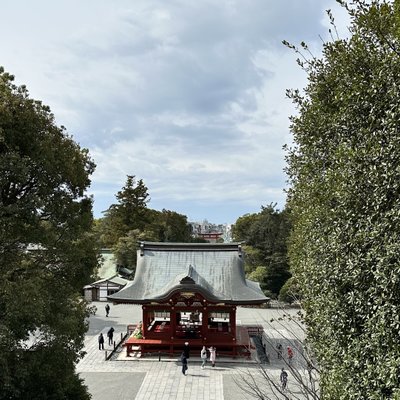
[77,302,307,400]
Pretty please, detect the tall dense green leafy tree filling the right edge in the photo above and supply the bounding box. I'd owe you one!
[288,0,400,400]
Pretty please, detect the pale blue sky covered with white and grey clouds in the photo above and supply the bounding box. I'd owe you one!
[0,0,347,223]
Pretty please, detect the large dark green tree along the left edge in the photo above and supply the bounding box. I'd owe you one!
[0,68,97,399]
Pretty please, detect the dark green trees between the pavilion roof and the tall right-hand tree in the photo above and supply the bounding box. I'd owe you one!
[232,205,291,296]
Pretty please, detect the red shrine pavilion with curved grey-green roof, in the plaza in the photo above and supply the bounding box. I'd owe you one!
[108,242,269,356]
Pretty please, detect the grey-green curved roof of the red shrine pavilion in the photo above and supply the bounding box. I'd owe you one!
[109,242,269,304]
